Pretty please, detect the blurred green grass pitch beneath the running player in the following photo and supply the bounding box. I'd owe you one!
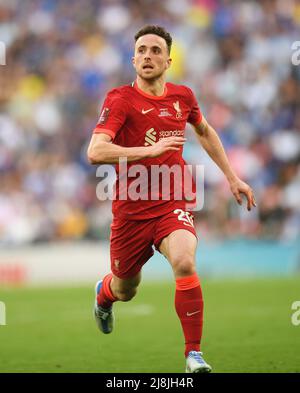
[0,277,300,373]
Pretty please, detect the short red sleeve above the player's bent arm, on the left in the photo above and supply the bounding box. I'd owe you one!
[93,92,127,139]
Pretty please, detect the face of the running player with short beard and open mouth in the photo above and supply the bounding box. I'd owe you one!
[132,34,172,80]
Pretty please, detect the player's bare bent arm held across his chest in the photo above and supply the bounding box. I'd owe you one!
[87,133,186,165]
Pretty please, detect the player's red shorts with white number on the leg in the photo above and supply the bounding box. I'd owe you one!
[110,209,197,279]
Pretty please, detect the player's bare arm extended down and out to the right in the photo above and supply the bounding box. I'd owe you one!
[194,117,256,210]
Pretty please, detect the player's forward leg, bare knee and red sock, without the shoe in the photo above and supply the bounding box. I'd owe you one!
[159,229,203,356]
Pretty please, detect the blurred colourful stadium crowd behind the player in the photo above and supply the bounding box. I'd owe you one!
[0,0,300,245]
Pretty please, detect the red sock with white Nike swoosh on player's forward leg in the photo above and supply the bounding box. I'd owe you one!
[175,273,203,356]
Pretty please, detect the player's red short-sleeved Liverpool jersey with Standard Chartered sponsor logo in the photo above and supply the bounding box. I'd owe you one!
[94,82,202,220]
